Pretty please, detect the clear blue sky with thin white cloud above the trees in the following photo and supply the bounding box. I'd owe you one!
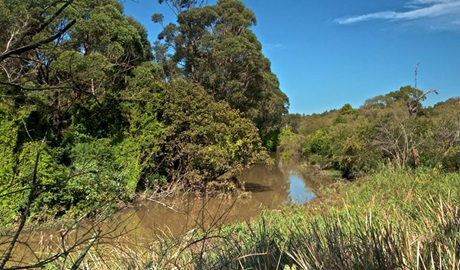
[123,0,460,114]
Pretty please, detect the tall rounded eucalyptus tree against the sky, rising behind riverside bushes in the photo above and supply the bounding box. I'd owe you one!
[153,0,288,149]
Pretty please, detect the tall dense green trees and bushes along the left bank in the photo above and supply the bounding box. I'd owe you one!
[0,0,288,224]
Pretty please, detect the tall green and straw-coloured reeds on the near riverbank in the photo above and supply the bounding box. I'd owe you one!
[37,168,460,269]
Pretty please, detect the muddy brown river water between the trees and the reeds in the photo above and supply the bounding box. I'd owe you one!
[0,158,338,265]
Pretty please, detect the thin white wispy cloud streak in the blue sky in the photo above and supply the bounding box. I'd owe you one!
[335,0,460,24]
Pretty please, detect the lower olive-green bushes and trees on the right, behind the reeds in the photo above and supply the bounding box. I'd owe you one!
[280,86,460,178]
